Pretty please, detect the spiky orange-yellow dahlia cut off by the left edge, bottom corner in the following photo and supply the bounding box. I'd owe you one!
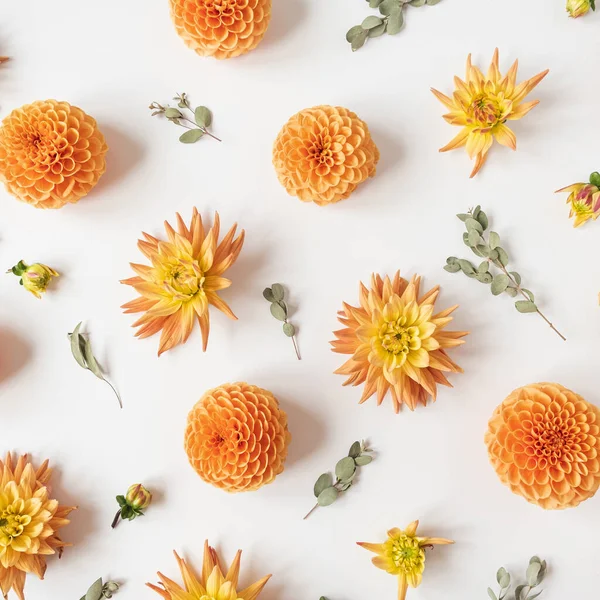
[0,453,77,600]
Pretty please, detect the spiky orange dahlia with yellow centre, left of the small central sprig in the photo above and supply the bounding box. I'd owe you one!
[121,208,244,356]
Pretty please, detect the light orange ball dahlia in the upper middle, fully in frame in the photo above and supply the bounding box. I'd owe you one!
[273,106,379,206]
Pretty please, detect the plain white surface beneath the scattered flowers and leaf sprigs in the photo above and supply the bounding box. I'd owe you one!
[0,0,600,600]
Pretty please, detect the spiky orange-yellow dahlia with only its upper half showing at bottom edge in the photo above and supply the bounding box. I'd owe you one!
[146,541,271,600]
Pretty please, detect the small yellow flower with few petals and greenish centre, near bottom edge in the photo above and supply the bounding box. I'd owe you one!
[357,521,454,600]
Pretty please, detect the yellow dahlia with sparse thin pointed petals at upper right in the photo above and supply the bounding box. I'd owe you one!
[431,48,548,177]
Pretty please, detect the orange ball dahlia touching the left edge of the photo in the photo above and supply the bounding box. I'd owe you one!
[0,100,108,208]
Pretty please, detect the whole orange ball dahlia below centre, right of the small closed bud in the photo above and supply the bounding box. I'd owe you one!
[185,383,291,492]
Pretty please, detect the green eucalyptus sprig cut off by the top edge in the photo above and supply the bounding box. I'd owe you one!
[346,0,441,52]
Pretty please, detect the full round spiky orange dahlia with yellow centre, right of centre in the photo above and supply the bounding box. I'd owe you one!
[331,271,468,412]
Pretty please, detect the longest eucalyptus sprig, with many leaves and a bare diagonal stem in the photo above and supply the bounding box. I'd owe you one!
[444,206,567,341]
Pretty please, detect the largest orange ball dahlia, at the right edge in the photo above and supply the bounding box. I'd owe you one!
[485,383,600,509]
